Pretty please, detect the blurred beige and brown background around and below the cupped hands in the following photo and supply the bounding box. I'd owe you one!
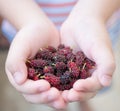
[0,15,120,111]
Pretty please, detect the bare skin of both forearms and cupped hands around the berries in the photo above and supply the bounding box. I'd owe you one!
[0,0,120,109]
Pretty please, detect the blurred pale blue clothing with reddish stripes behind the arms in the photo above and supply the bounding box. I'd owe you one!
[2,0,120,44]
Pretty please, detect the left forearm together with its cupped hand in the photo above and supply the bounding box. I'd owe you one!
[0,0,66,109]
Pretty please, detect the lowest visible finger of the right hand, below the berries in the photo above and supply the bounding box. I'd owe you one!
[64,89,96,102]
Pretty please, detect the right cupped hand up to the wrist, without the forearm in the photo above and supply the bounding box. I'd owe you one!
[61,15,115,102]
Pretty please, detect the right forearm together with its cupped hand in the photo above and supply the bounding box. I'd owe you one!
[61,0,120,102]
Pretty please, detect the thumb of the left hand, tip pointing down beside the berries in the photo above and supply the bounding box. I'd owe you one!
[5,50,27,85]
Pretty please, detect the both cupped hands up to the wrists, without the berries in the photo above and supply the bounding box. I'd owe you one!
[6,12,115,109]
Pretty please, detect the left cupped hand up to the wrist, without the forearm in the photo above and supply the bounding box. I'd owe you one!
[6,23,66,109]
